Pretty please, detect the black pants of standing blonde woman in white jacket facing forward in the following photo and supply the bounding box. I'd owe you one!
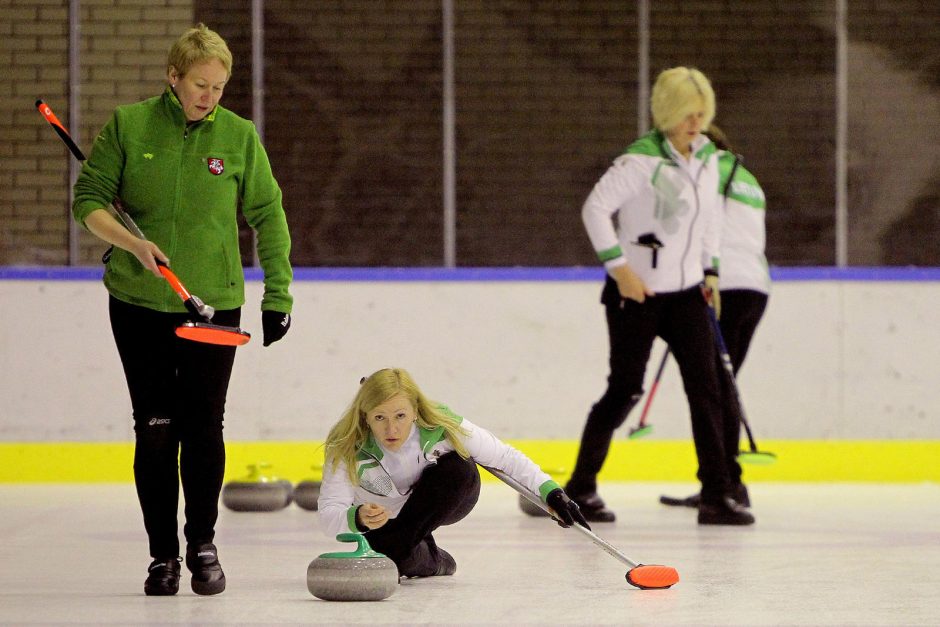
[567,277,741,501]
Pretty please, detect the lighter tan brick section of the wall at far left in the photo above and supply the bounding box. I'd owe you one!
[0,0,192,264]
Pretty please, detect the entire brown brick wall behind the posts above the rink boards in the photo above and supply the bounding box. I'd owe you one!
[7,0,940,266]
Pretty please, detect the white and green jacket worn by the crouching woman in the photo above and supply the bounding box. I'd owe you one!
[318,407,561,538]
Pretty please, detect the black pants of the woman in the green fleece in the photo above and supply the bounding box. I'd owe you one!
[109,297,241,559]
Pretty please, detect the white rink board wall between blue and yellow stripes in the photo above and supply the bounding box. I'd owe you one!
[0,271,940,442]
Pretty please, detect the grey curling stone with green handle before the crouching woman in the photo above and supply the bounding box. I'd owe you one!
[307,533,398,601]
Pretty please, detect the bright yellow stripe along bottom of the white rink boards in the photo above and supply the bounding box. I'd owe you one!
[0,439,940,483]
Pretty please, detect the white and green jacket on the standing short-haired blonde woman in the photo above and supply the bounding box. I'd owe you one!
[581,130,721,292]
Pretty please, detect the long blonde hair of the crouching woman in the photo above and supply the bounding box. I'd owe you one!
[324,368,470,485]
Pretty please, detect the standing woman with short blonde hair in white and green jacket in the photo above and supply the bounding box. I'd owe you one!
[566,67,754,525]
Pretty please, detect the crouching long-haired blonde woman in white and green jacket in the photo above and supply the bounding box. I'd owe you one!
[318,368,590,577]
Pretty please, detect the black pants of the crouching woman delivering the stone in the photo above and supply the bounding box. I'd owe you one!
[366,453,480,575]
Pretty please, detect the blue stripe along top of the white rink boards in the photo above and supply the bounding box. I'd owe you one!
[0,266,940,283]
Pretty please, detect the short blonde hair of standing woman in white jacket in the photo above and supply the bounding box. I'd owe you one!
[650,66,715,132]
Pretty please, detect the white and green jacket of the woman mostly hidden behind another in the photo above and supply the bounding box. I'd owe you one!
[718,150,770,294]
